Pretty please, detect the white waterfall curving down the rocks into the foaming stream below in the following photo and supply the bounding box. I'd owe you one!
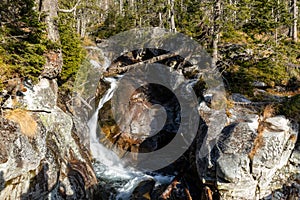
[88,77,173,200]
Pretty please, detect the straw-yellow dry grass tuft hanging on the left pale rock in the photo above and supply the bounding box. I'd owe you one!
[5,109,37,137]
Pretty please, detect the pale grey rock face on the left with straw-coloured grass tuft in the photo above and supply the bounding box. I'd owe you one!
[0,79,96,199]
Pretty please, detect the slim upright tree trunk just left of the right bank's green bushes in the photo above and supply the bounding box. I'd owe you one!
[212,0,221,68]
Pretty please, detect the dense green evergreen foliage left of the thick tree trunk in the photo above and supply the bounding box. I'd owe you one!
[0,0,47,81]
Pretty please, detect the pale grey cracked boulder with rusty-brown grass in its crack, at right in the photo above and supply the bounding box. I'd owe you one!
[196,106,299,199]
